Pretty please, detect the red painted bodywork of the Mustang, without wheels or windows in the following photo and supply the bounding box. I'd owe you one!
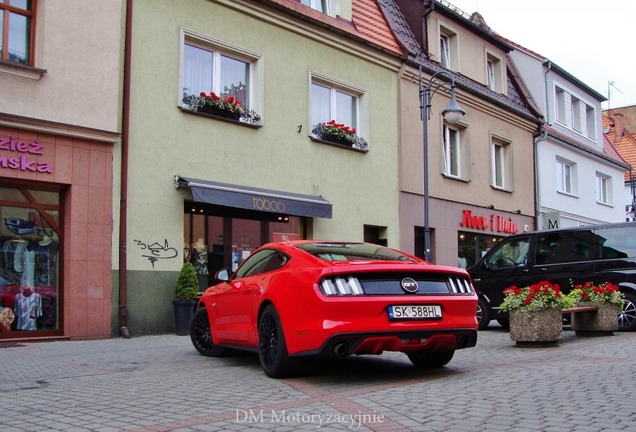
[200,241,477,355]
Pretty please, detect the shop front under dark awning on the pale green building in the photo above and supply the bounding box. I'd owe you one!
[175,176,332,291]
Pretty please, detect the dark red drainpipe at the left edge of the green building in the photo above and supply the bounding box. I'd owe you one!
[119,0,133,339]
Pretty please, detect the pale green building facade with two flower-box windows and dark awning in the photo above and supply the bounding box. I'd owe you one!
[118,0,404,335]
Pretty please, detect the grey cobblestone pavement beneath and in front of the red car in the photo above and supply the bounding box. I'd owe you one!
[0,328,636,432]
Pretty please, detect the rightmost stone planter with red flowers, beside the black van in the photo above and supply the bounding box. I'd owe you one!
[568,282,624,336]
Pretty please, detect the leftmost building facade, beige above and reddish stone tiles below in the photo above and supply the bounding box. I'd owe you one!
[0,0,122,340]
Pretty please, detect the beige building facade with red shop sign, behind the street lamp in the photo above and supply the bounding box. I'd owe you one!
[390,0,539,267]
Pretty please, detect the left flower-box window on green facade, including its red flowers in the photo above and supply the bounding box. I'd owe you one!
[179,29,262,124]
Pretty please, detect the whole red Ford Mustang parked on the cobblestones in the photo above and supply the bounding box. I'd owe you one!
[190,241,477,378]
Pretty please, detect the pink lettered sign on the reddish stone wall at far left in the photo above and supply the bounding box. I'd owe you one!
[0,136,53,174]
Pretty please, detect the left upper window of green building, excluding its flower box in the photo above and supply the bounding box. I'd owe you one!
[180,29,262,120]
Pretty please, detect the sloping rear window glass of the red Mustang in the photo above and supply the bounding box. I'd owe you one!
[296,243,415,262]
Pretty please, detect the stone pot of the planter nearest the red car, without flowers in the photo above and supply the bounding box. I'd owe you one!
[510,307,563,345]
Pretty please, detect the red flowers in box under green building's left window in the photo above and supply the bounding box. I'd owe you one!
[183,92,261,124]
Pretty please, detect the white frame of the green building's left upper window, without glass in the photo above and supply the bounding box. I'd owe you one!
[177,27,264,126]
